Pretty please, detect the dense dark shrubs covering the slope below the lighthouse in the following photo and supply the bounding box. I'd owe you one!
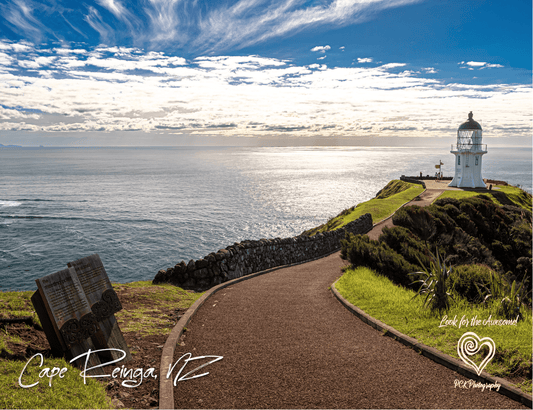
[344,191,532,304]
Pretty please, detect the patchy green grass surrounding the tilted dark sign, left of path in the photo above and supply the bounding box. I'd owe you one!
[0,281,202,409]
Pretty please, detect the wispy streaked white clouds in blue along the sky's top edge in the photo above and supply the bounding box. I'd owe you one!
[0,0,422,55]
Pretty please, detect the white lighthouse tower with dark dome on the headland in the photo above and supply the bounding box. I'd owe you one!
[448,111,487,188]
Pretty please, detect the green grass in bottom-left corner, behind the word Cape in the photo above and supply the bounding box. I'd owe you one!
[0,357,113,409]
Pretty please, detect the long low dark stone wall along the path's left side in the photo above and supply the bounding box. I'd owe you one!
[152,214,372,289]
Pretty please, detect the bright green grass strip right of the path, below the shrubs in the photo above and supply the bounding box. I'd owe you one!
[336,267,532,393]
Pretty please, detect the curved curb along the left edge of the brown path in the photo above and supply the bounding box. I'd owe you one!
[159,249,340,409]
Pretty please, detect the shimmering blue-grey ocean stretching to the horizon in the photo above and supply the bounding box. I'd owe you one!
[0,147,532,291]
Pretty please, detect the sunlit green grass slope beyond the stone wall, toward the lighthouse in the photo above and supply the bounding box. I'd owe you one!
[304,180,424,236]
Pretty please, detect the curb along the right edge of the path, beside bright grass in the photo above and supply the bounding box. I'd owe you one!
[331,278,532,408]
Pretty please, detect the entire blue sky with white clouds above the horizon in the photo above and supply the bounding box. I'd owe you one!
[0,0,533,147]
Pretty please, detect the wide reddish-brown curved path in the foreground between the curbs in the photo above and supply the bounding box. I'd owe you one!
[173,252,526,408]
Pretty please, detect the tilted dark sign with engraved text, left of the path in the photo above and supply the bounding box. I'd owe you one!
[31,254,132,373]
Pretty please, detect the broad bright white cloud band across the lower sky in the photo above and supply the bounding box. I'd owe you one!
[0,42,532,138]
